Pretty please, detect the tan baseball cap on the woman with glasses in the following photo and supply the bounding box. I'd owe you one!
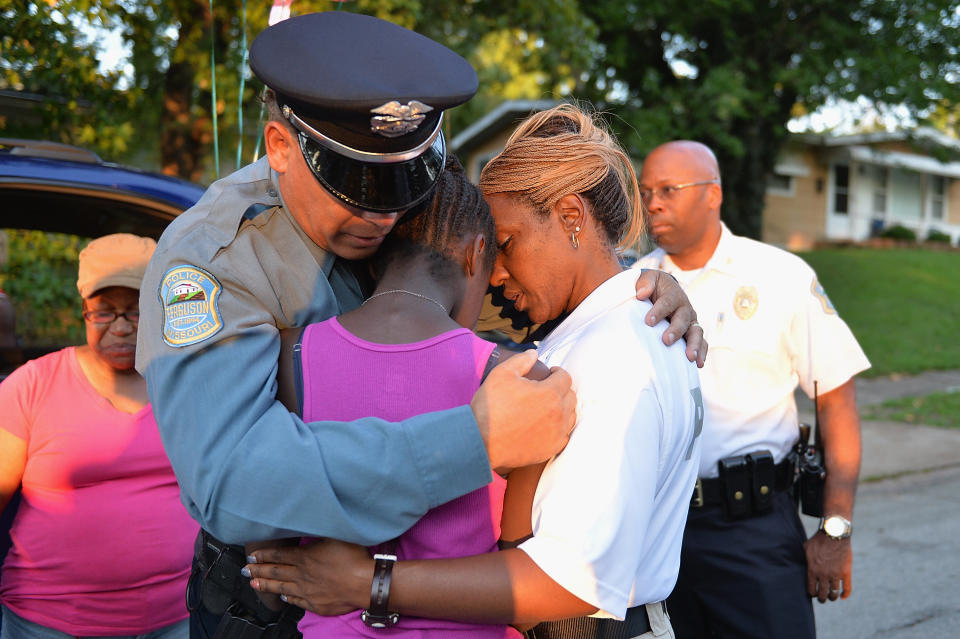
[77,233,157,299]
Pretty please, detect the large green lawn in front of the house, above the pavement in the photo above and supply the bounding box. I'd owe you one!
[799,248,960,376]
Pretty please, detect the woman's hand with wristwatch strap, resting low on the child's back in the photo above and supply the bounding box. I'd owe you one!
[246,539,373,616]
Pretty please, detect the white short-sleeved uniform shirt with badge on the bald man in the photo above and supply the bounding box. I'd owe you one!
[634,225,870,477]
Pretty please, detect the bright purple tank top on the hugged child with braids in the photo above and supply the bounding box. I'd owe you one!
[300,318,521,639]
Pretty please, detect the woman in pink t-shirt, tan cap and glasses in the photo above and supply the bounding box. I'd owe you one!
[0,234,197,639]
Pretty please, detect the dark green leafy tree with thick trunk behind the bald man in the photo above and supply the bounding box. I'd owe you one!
[580,0,960,237]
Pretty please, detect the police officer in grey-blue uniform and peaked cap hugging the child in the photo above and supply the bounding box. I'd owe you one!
[137,12,706,636]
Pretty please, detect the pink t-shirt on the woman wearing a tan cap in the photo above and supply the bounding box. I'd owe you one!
[0,347,198,635]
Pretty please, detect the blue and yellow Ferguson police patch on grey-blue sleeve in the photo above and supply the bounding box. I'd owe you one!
[160,264,223,348]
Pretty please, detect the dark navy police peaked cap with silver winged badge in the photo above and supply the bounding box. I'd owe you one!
[250,11,477,211]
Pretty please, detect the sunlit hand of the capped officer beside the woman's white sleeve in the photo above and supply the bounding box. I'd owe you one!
[470,350,577,473]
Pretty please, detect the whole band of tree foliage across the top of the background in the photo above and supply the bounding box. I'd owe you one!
[0,0,960,235]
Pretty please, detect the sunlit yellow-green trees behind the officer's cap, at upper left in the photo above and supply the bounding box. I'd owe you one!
[0,0,592,182]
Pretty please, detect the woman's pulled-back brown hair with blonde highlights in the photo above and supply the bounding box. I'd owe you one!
[480,104,644,248]
